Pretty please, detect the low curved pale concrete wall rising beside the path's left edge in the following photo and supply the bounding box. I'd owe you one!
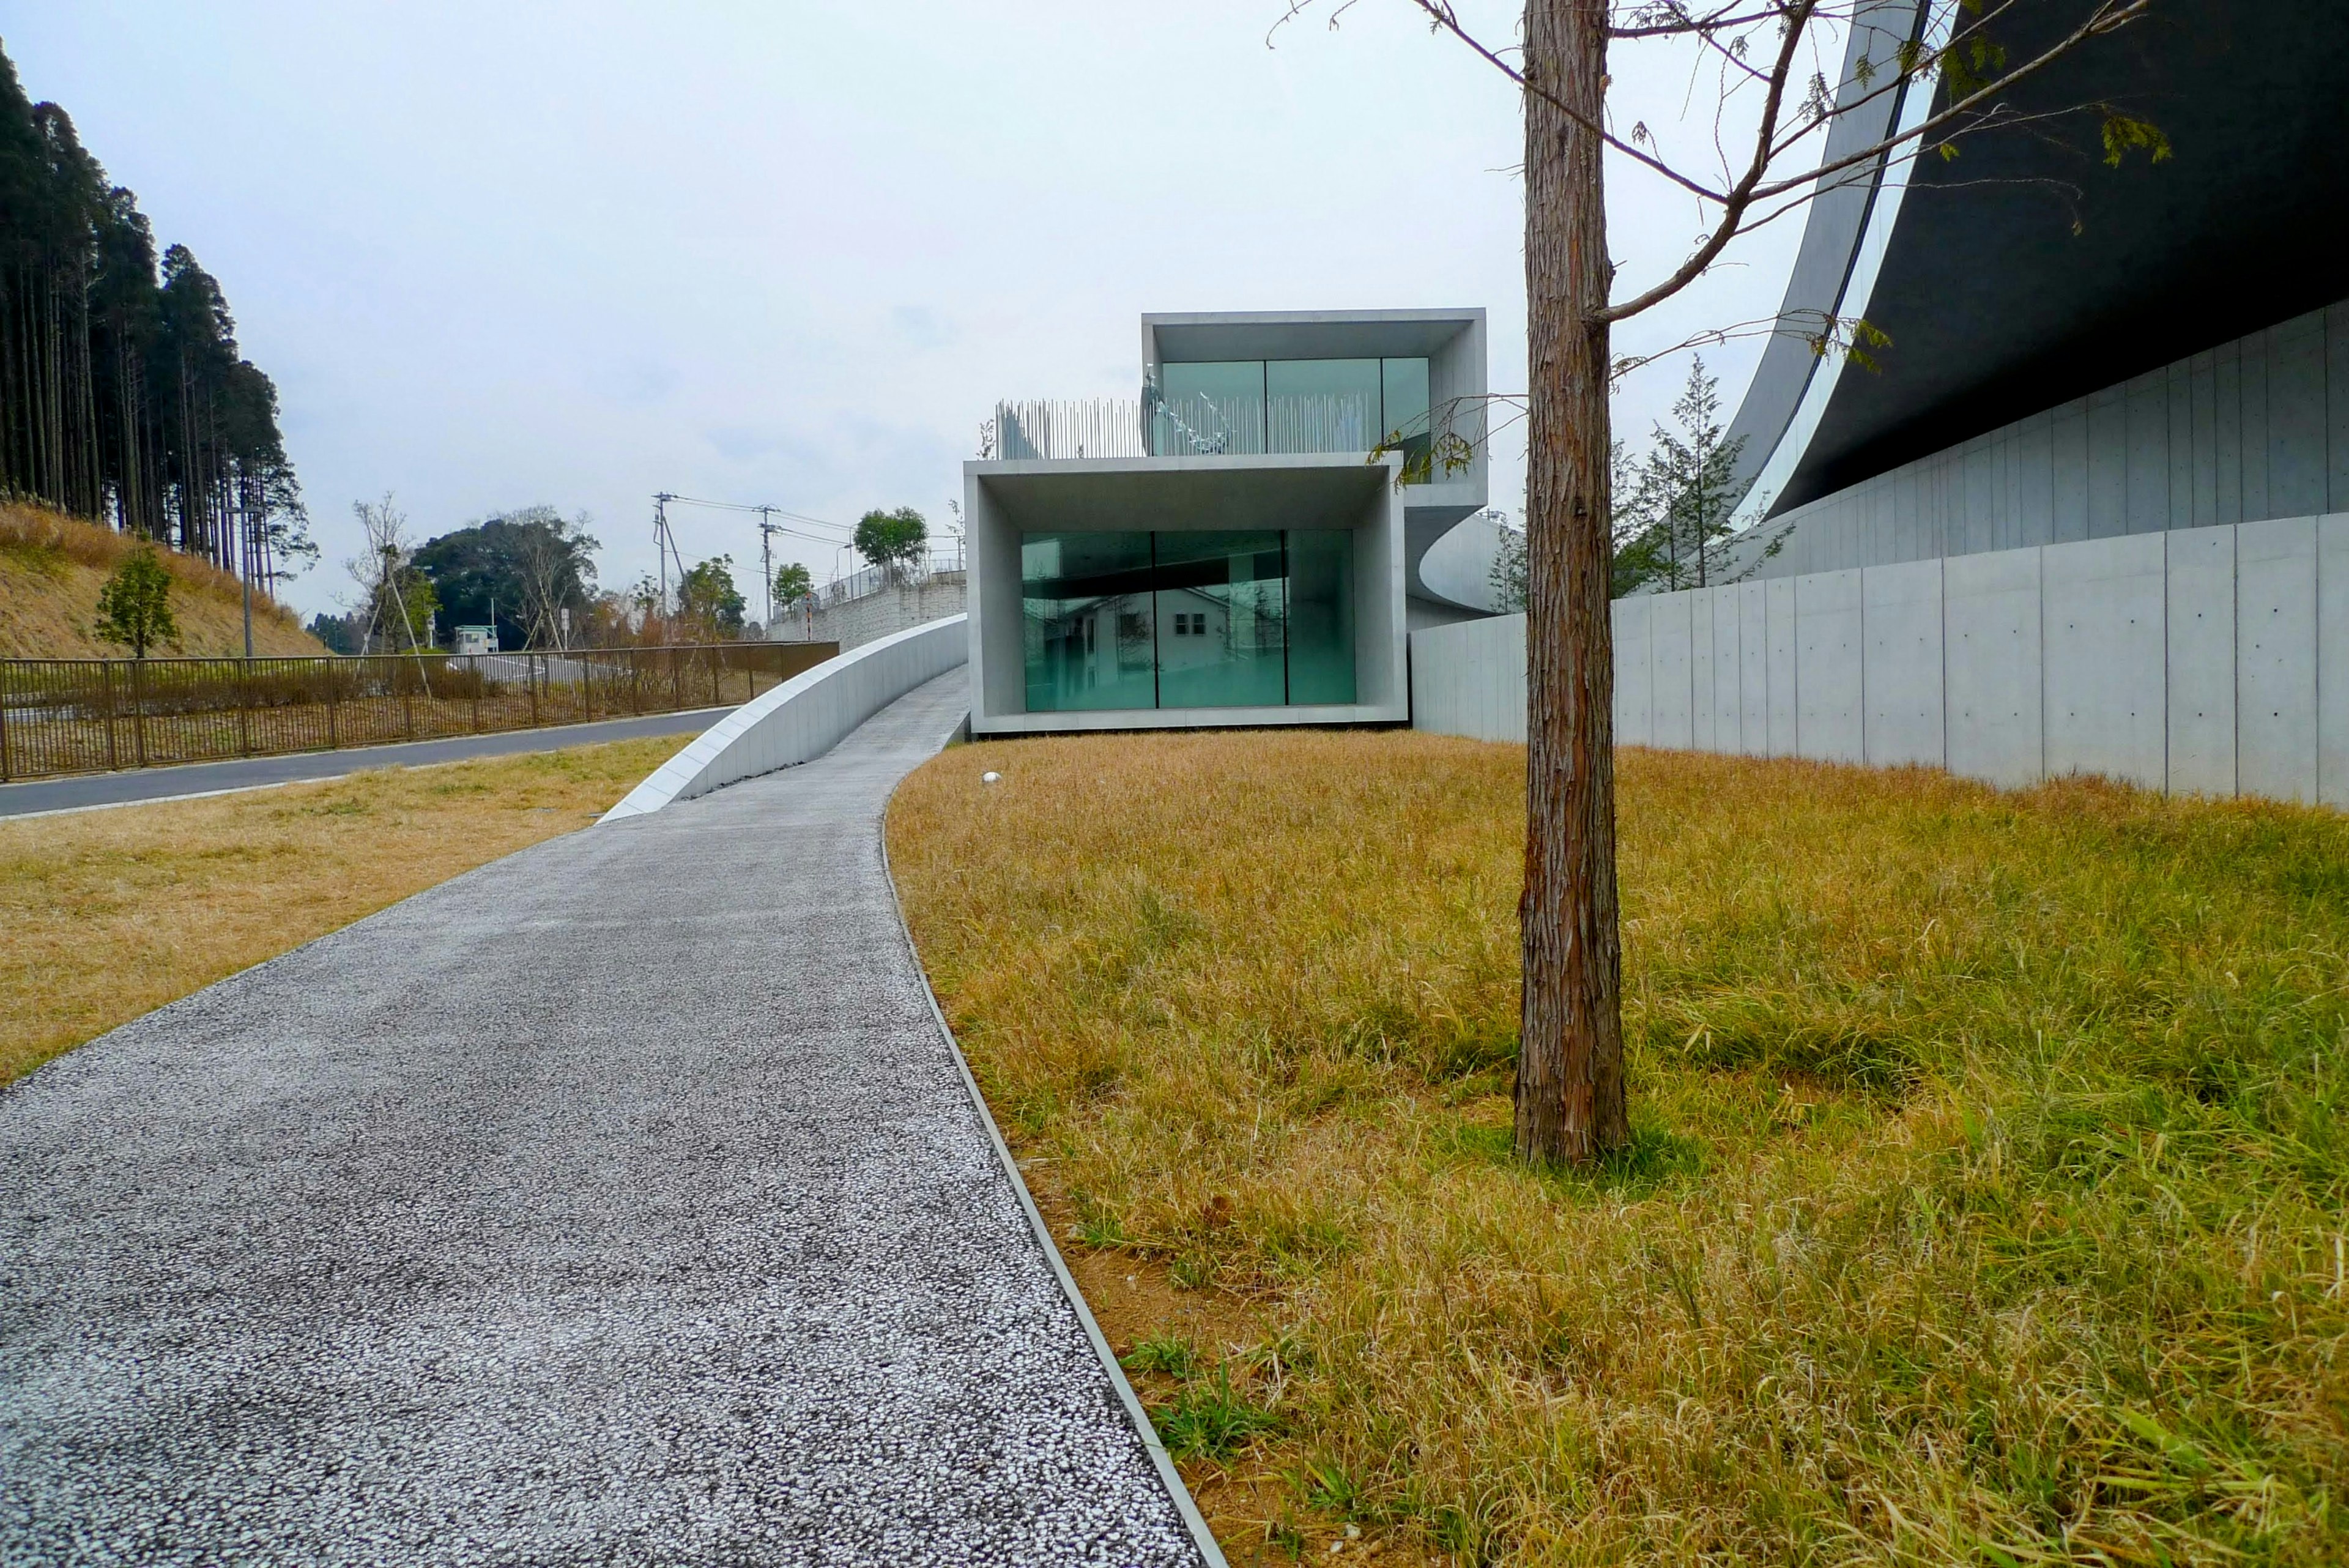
[596,616,970,823]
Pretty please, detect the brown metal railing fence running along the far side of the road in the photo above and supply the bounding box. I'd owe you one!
[0,642,841,781]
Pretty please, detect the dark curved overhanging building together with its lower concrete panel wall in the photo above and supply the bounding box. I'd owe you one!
[1412,0,2349,806]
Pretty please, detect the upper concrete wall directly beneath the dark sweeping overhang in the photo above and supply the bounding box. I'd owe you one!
[1731,301,2349,578]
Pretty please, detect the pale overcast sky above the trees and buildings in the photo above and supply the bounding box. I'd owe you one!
[0,0,1799,614]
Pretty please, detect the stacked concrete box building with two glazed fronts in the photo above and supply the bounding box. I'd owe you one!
[963,310,1487,734]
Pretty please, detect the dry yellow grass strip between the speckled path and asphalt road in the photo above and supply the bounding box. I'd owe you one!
[0,736,691,1083]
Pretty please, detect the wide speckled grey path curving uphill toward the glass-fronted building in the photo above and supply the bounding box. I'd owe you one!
[0,670,1200,1568]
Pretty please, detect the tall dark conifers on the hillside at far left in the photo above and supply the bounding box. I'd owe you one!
[0,52,317,588]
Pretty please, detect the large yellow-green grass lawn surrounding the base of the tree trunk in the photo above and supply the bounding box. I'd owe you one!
[890,731,2349,1566]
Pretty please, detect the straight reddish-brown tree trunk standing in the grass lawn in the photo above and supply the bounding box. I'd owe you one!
[1518,0,1630,1161]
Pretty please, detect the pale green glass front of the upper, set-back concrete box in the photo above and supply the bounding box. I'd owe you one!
[1149,360,1428,479]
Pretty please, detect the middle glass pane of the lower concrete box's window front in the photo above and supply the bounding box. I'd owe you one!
[1153,531,1287,708]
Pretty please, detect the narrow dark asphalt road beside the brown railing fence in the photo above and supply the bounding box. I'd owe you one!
[0,708,733,816]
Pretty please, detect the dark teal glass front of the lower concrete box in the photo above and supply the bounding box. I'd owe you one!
[1020,529,1356,712]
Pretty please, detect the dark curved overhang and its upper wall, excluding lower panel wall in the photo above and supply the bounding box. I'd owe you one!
[1731,0,2349,578]
